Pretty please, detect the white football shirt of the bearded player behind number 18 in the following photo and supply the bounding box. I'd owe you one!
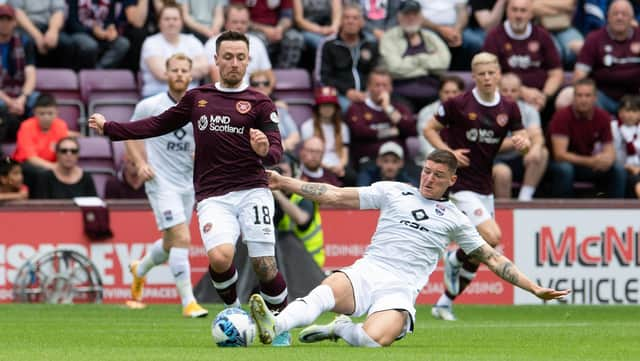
[131,92,196,192]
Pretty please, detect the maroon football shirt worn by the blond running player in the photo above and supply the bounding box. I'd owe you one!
[435,88,523,194]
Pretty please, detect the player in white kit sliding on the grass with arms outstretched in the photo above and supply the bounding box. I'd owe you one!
[249,150,570,347]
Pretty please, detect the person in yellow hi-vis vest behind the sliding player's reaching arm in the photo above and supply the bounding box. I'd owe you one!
[271,155,325,268]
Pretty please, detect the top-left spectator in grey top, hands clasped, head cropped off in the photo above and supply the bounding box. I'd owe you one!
[8,0,73,68]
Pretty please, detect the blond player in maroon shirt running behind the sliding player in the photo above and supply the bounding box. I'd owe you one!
[424,52,530,321]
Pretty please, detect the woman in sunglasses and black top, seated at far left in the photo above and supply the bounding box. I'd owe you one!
[33,137,97,199]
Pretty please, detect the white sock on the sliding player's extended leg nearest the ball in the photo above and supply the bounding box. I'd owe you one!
[276,285,336,335]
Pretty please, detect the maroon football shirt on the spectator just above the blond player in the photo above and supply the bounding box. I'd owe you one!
[483,21,562,90]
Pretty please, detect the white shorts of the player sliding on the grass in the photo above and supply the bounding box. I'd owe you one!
[338,259,418,339]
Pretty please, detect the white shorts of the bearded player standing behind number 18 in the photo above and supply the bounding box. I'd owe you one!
[147,189,195,231]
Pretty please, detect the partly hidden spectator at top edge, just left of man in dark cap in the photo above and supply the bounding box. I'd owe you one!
[360,0,402,41]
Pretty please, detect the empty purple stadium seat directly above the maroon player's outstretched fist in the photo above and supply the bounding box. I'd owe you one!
[78,69,140,122]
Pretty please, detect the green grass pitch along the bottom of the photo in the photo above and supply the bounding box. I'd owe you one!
[0,304,640,361]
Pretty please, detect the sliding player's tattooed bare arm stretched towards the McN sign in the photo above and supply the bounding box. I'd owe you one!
[469,244,571,300]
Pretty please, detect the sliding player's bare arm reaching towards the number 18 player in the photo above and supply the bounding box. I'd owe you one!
[266,170,360,209]
